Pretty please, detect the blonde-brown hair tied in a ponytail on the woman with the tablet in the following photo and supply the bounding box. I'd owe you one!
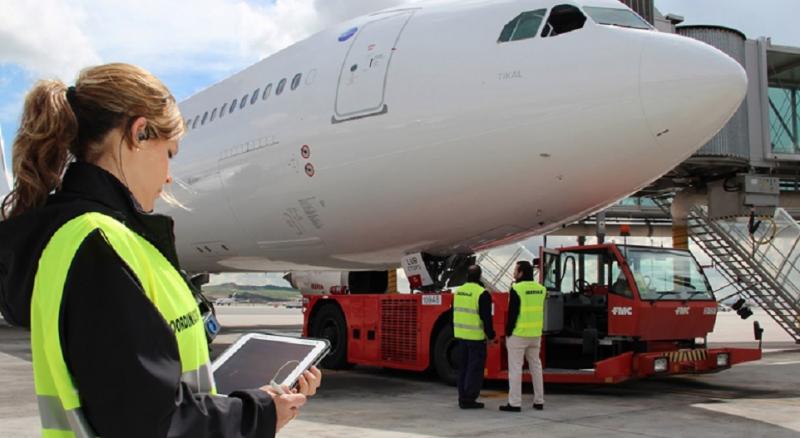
[0,63,184,218]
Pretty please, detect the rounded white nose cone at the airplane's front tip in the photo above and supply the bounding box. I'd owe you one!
[639,34,747,151]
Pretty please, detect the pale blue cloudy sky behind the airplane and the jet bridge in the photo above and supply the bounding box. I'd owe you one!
[0,0,800,290]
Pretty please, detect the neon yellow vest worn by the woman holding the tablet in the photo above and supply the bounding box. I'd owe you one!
[31,213,216,438]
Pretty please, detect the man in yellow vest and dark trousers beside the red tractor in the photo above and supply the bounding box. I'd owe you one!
[453,265,494,409]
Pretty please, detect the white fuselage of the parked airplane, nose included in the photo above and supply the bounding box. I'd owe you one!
[166,0,747,272]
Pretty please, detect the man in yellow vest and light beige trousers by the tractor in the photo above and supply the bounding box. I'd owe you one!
[500,261,547,412]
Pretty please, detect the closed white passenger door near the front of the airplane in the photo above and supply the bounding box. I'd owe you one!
[333,10,414,123]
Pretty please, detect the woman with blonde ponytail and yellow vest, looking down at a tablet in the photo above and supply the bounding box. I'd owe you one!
[0,64,321,438]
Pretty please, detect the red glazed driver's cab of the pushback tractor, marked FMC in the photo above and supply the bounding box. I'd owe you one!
[539,244,717,368]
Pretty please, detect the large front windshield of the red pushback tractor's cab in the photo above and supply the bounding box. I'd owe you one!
[626,247,714,300]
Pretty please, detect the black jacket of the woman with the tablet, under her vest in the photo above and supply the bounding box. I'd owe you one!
[0,162,276,438]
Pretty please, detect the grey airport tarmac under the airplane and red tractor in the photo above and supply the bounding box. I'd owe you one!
[0,306,800,438]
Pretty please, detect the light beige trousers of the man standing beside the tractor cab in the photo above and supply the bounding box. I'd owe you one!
[506,336,544,407]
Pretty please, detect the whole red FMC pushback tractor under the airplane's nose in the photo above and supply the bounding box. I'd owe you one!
[303,244,761,383]
